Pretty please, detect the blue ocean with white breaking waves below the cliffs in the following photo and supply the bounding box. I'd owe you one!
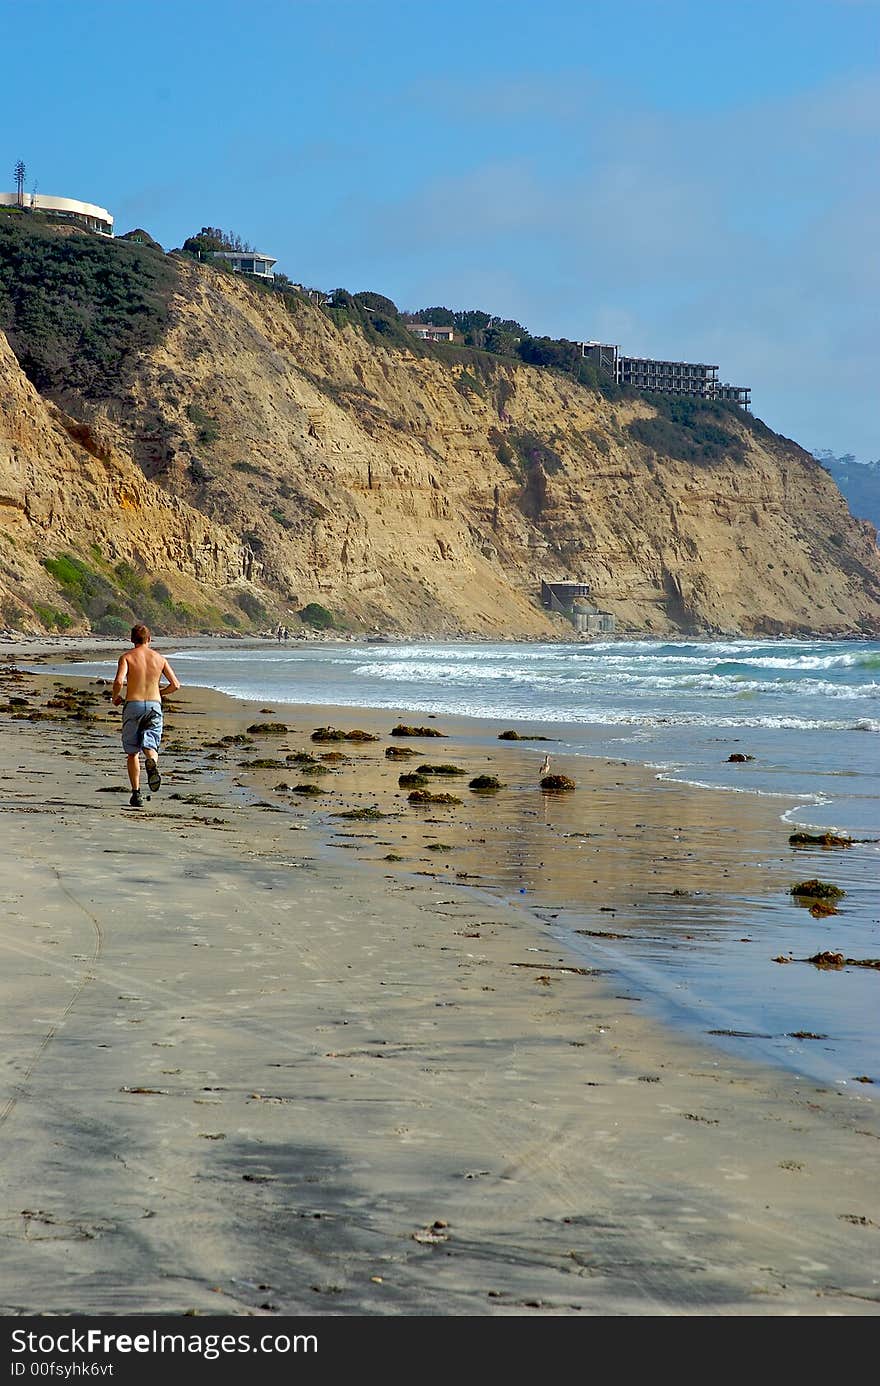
[158,640,880,833]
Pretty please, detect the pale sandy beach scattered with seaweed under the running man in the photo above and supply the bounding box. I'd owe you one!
[0,649,880,1317]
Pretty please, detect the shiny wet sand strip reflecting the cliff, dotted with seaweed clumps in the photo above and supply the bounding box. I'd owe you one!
[17,643,880,1098]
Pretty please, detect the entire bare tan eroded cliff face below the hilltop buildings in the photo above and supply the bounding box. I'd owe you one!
[0,246,880,638]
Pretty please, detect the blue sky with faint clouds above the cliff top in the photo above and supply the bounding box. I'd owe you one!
[0,0,880,460]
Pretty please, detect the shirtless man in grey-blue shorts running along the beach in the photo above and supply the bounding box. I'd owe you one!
[114,625,180,808]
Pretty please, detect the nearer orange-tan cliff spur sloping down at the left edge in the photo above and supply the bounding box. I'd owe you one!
[0,333,248,629]
